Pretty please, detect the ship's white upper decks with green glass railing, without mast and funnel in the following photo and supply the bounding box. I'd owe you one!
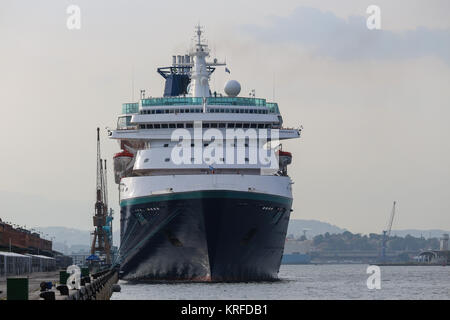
[110,97,300,139]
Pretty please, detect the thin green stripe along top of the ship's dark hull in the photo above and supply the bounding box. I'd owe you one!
[120,190,292,207]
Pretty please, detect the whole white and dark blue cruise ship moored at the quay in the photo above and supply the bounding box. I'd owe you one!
[108,27,301,282]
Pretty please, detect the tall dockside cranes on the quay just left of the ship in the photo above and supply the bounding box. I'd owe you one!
[91,128,112,264]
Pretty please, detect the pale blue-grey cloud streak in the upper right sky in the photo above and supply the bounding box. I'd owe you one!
[241,7,450,63]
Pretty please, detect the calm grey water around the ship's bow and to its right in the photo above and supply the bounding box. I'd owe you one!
[111,264,450,300]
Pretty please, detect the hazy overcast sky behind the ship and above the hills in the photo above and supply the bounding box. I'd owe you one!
[0,0,450,233]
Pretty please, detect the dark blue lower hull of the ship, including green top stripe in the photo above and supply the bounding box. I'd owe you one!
[120,191,292,281]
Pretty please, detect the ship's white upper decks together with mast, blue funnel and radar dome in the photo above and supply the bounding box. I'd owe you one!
[109,28,300,140]
